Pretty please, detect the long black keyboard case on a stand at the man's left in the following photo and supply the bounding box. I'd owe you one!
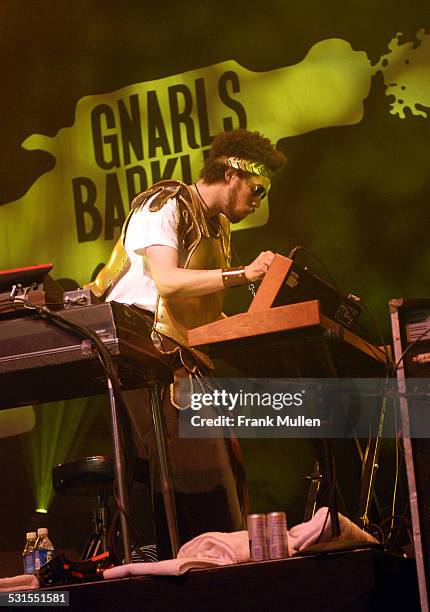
[0,302,171,408]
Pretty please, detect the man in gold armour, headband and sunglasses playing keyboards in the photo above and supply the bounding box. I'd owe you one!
[88,129,286,558]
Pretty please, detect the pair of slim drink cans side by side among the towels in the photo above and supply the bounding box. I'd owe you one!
[248,512,288,561]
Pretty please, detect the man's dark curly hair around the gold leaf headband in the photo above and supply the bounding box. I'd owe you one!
[200,128,287,183]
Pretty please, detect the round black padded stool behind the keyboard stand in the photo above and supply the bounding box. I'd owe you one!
[52,455,150,559]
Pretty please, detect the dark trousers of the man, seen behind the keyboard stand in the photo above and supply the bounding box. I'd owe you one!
[124,389,243,559]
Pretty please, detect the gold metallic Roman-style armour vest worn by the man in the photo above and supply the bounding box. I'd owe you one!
[85,180,230,346]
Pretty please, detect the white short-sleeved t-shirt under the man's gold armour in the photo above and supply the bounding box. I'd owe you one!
[106,198,178,312]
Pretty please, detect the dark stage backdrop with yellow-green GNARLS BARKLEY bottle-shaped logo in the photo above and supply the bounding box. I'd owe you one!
[0,0,430,548]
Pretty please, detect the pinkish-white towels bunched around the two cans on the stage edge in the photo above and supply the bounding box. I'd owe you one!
[103,507,377,580]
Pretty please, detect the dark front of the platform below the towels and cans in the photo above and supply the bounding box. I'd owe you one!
[42,549,420,612]
